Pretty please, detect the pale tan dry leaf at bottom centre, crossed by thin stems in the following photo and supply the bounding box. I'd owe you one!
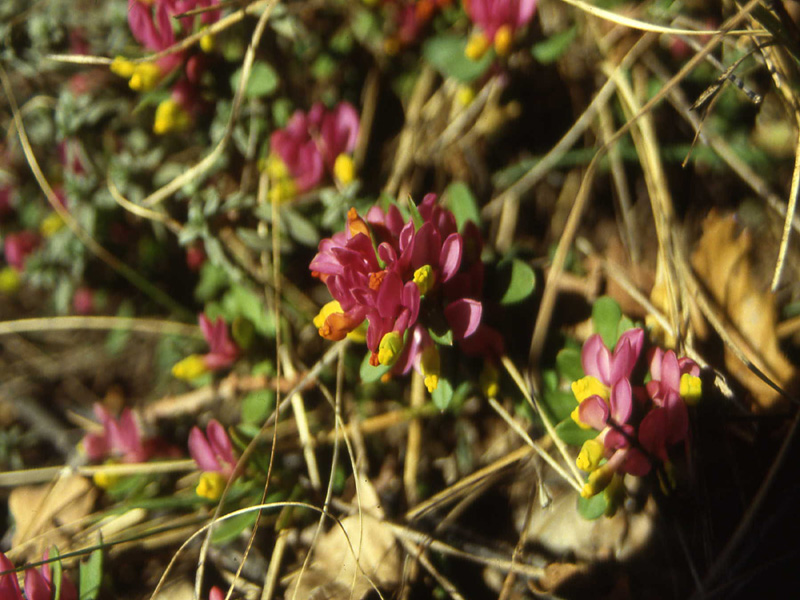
[286,514,402,600]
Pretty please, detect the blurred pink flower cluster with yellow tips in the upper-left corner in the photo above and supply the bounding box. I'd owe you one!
[111,0,221,134]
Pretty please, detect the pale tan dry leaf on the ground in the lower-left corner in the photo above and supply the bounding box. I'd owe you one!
[8,475,97,559]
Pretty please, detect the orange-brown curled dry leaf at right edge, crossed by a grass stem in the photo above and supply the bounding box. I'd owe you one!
[692,211,795,409]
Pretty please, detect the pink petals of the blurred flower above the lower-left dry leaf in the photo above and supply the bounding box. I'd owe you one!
[82,403,150,463]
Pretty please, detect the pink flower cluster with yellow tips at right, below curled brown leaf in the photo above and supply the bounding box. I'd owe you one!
[572,329,701,504]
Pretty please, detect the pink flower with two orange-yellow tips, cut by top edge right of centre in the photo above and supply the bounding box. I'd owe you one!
[464,0,538,60]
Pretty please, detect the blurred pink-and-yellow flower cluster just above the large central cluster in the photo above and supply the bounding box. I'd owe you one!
[267,102,359,202]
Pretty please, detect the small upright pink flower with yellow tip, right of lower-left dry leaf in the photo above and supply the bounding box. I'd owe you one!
[189,420,236,500]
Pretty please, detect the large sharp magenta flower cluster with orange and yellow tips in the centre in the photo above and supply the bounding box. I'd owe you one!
[310,194,502,391]
